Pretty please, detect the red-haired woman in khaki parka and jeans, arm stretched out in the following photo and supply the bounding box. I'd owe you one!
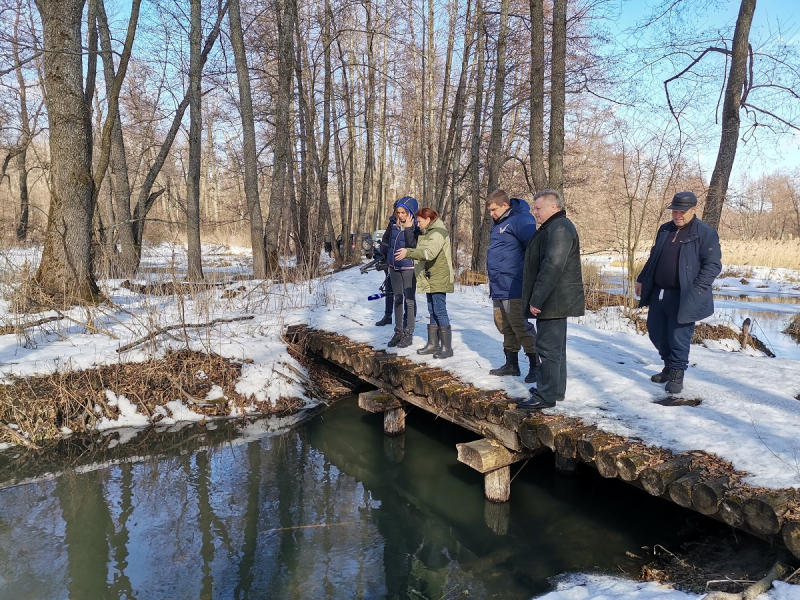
[395,206,455,358]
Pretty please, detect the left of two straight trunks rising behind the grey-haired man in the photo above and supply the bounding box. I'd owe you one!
[528,0,547,192]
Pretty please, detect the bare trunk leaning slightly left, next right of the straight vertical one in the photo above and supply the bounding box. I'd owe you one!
[228,0,267,279]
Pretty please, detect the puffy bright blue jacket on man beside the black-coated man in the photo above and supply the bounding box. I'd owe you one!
[486,198,536,300]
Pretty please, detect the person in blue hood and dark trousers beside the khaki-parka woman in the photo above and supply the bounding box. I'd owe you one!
[386,196,419,348]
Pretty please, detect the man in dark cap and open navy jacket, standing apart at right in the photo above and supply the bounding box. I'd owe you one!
[634,192,722,394]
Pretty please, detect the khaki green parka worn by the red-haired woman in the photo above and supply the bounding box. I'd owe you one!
[406,218,455,294]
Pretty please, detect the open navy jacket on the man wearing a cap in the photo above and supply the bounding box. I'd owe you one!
[636,217,722,323]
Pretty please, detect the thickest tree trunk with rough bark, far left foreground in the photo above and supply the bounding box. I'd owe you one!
[35,0,99,305]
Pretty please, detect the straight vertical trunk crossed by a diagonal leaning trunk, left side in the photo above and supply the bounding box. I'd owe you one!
[186,0,203,281]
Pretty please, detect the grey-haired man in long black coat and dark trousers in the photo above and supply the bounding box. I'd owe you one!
[517,190,585,409]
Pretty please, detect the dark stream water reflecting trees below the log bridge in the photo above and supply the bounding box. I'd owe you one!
[0,398,788,600]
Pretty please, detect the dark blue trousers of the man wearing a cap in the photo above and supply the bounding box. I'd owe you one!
[647,288,695,371]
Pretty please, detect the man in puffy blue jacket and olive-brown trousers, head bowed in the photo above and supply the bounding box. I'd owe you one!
[486,190,539,383]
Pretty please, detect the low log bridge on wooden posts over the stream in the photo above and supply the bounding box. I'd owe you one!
[286,325,800,557]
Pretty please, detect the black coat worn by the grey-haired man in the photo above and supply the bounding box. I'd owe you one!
[522,210,585,319]
